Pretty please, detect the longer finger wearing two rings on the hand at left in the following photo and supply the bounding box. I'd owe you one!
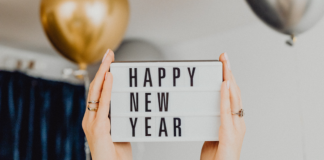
[86,49,114,122]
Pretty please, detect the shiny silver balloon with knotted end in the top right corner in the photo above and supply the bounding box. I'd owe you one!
[246,0,324,45]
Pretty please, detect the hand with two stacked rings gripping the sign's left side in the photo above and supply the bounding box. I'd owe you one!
[82,50,132,160]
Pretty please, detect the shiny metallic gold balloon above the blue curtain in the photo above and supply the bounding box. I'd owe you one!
[40,0,129,69]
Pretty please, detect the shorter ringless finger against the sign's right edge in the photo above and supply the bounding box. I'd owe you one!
[220,81,233,127]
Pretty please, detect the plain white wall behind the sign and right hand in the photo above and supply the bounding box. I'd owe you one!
[133,20,324,160]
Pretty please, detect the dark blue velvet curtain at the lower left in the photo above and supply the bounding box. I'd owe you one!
[0,71,85,160]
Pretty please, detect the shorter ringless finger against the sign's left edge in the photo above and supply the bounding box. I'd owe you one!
[97,72,113,119]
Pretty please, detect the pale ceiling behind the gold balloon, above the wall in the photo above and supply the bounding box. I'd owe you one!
[0,0,259,55]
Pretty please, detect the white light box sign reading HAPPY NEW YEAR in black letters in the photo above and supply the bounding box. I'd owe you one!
[110,61,223,142]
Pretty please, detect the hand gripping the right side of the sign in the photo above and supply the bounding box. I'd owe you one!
[200,53,245,160]
